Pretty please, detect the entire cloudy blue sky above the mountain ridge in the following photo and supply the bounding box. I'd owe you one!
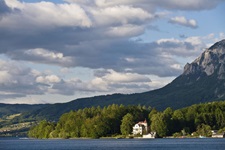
[0,0,225,104]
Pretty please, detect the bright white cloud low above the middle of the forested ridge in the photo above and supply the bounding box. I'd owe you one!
[91,70,151,93]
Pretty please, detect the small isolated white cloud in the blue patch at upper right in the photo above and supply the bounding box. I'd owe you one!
[169,16,198,28]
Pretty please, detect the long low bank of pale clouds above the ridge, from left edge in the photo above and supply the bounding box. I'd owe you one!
[0,61,151,100]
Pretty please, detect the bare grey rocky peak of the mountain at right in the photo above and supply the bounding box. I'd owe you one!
[183,39,225,79]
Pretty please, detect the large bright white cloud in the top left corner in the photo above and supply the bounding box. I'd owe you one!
[0,0,92,30]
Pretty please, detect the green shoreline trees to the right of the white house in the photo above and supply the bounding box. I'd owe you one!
[149,101,225,137]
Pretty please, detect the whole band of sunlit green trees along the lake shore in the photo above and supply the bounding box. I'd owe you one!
[28,101,225,138]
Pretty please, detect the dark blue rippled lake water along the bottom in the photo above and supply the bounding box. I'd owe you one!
[0,138,225,150]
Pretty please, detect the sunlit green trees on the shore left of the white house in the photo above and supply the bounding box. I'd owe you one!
[29,104,150,138]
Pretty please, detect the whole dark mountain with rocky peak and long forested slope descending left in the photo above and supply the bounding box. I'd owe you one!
[0,40,225,120]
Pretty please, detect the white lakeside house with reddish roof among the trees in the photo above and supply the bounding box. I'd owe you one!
[133,120,148,135]
